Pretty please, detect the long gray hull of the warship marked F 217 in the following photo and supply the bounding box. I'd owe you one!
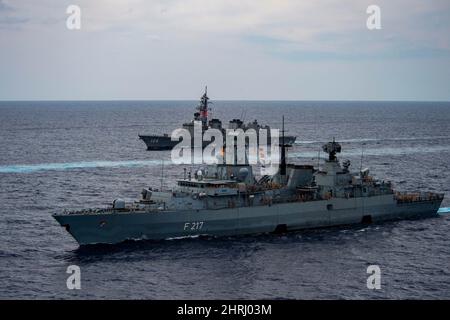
[54,195,442,245]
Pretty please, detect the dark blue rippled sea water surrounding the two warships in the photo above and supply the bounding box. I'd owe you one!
[0,101,450,299]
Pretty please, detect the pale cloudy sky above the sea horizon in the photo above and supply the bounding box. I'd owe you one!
[0,0,450,101]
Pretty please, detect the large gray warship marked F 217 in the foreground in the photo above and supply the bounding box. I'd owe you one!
[53,131,444,245]
